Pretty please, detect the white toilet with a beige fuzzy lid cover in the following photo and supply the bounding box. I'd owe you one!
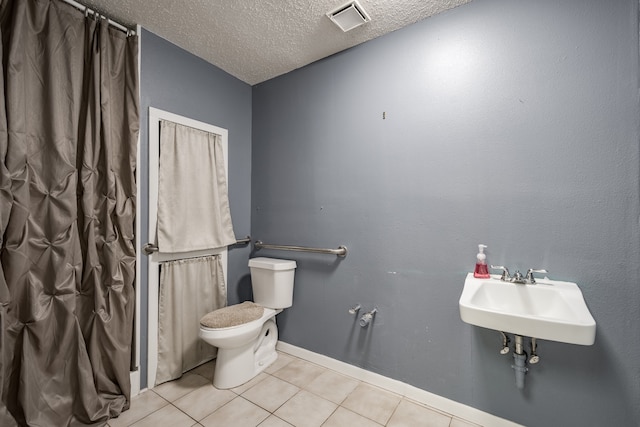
[199,257,296,389]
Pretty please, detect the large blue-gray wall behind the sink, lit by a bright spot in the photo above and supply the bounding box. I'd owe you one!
[251,0,640,426]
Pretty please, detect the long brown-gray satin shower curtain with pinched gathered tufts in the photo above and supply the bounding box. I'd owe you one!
[0,0,139,426]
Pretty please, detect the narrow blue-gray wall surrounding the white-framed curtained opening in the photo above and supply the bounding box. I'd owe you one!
[139,30,251,387]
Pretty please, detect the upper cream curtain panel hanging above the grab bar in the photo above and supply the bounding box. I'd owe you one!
[158,120,236,253]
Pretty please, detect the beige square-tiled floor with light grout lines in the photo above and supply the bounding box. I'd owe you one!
[108,352,477,427]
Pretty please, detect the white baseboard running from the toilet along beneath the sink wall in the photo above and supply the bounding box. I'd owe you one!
[276,341,524,427]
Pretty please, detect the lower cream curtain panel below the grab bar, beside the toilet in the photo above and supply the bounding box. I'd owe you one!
[156,255,227,385]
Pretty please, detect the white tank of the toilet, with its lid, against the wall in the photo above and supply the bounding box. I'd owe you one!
[249,257,296,309]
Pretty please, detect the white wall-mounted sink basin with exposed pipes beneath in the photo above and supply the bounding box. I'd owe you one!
[459,273,596,345]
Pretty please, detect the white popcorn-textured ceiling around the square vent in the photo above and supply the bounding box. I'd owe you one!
[79,0,471,85]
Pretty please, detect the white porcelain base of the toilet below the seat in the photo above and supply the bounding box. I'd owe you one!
[213,319,278,389]
